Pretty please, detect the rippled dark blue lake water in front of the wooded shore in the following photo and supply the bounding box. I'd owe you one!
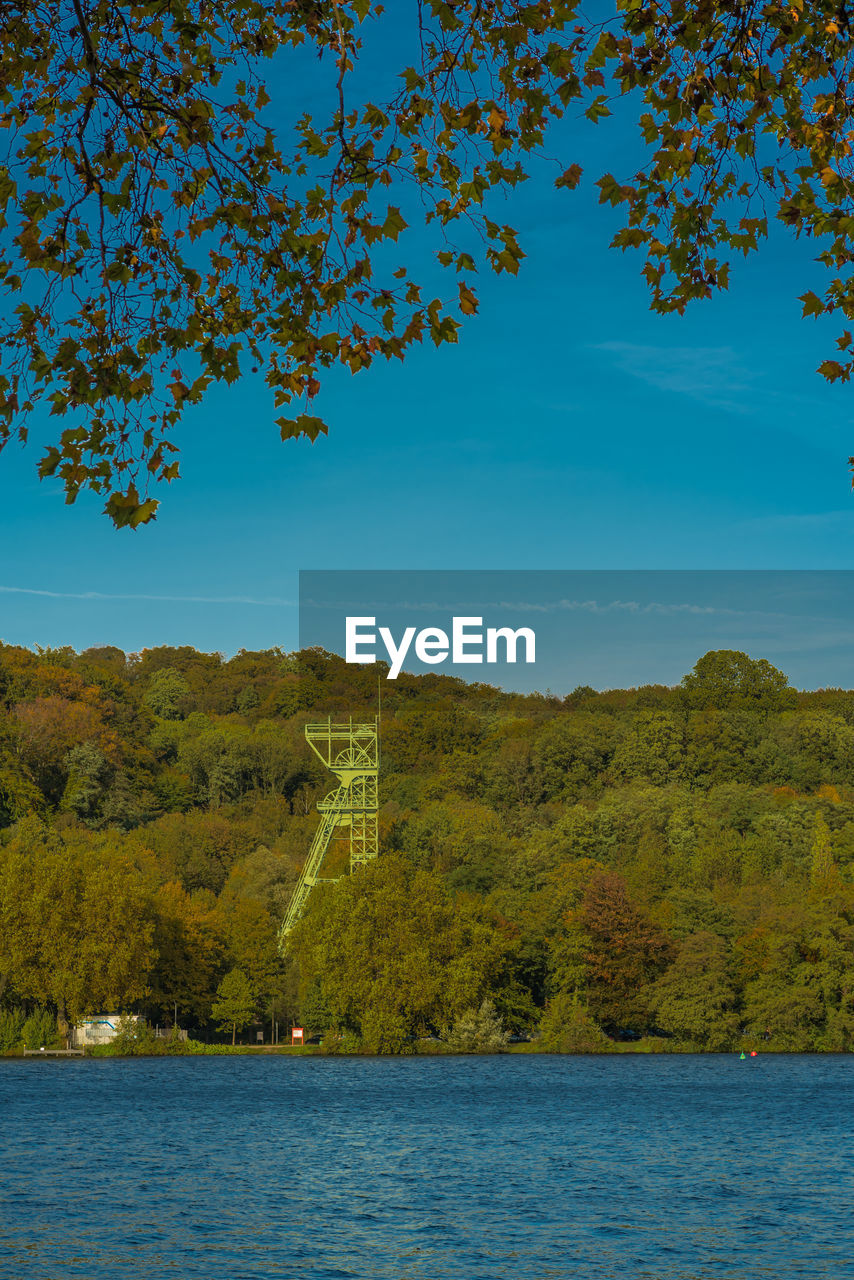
[0,1055,854,1280]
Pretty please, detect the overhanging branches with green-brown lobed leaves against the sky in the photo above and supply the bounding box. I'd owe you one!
[0,0,854,526]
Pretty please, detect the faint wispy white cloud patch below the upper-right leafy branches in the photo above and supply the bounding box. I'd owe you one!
[592,342,754,413]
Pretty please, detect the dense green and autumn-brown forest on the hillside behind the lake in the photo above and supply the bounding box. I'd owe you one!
[0,646,854,1052]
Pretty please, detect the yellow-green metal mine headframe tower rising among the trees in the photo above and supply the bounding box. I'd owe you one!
[279,719,379,950]
